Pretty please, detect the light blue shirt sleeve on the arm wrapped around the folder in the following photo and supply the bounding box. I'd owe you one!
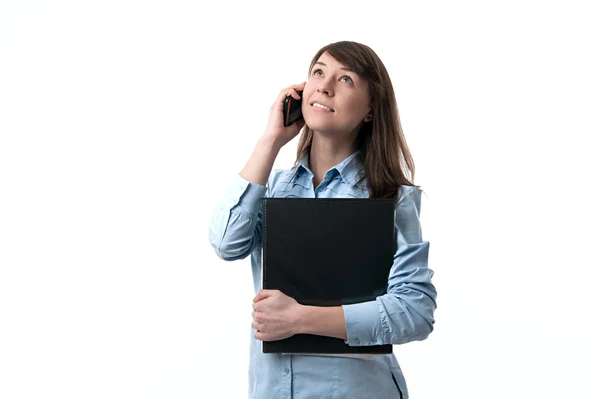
[342,186,437,346]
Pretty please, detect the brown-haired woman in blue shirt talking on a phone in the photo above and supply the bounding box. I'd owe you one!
[209,42,437,399]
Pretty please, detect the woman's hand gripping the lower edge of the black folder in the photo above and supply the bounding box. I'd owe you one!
[252,290,302,341]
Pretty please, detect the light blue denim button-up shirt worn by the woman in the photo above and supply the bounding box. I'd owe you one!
[209,152,437,399]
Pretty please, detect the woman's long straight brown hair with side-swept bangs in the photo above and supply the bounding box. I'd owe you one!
[296,41,415,199]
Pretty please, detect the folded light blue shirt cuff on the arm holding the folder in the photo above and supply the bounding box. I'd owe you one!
[342,300,382,346]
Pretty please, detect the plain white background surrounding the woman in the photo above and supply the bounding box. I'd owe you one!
[0,0,600,399]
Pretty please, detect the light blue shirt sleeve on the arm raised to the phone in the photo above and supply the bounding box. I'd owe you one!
[208,174,268,261]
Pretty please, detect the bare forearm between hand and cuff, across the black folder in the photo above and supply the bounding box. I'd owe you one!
[298,306,347,340]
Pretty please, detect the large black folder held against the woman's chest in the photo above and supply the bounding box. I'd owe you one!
[262,198,394,354]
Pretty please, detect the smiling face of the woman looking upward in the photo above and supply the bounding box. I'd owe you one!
[302,53,371,139]
